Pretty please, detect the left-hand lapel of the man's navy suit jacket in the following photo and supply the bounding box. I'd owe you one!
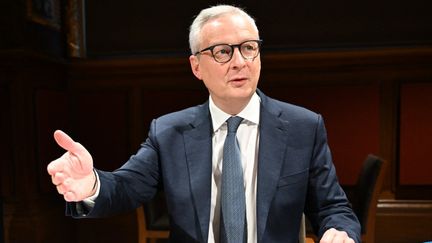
[184,103,212,242]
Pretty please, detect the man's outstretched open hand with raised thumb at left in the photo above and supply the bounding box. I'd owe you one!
[47,130,96,202]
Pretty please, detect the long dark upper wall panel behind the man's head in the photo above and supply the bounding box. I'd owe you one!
[86,0,432,56]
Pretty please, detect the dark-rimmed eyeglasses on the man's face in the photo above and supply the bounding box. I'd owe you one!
[194,40,262,63]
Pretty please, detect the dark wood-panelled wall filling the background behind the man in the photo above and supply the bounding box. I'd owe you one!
[0,0,432,243]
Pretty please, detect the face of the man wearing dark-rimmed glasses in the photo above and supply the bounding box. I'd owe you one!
[189,15,261,110]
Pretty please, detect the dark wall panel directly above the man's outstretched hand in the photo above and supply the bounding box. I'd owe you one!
[66,87,130,171]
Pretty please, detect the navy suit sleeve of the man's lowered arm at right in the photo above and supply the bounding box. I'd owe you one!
[305,116,361,242]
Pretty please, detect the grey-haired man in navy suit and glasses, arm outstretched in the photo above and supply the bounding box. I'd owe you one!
[48,5,360,242]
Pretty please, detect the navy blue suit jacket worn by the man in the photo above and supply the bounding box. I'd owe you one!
[68,90,360,243]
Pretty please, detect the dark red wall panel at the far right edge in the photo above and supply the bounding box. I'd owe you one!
[399,83,432,185]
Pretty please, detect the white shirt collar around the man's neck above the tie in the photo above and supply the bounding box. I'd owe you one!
[209,93,261,132]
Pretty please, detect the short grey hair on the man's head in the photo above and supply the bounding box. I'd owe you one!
[189,5,258,54]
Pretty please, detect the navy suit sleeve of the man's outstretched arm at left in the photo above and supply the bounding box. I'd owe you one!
[66,120,161,218]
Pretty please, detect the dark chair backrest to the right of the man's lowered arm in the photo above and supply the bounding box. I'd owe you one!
[352,154,387,243]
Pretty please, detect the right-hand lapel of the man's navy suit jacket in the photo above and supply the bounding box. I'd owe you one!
[257,94,288,242]
